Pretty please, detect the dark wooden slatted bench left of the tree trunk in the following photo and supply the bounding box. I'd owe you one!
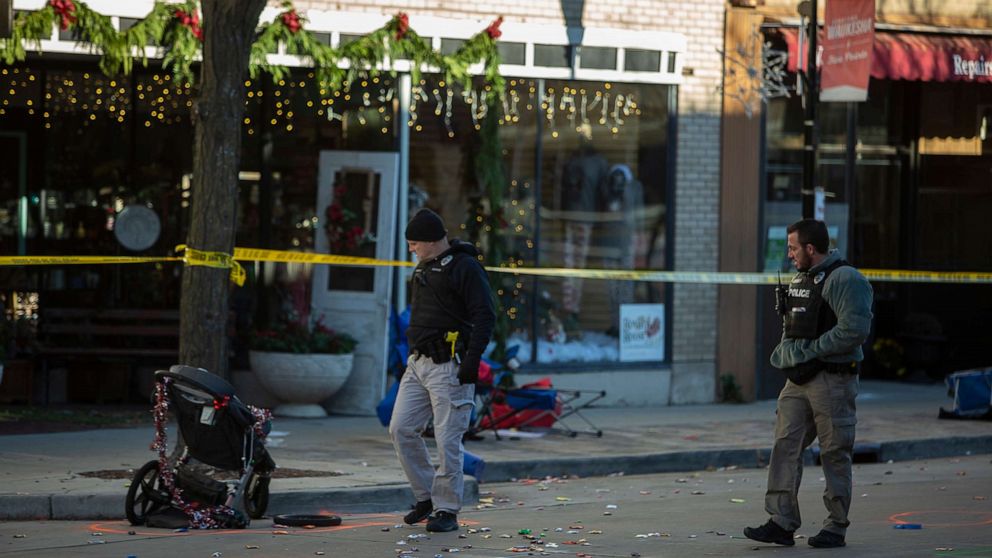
[37,307,179,405]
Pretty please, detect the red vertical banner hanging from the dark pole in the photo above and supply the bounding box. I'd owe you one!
[820,0,875,103]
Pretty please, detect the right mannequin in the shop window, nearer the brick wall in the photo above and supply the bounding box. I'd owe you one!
[600,164,646,335]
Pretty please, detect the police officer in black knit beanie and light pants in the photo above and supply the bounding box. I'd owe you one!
[389,209,496,532]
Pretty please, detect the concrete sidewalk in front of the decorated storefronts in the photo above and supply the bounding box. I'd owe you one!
[0,381,992,519]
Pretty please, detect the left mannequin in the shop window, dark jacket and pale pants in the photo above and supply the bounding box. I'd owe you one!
[561,124,610,331]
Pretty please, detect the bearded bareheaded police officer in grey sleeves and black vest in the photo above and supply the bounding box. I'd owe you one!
[744,219,872,548]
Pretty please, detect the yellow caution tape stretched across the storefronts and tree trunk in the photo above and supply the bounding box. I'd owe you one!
[0,249,992,285]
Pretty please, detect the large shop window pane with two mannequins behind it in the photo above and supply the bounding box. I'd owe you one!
[537,81,669,363]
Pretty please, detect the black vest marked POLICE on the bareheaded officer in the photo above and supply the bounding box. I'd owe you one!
[785,260,851,339]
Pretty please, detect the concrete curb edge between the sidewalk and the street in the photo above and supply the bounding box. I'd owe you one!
[0,436,992,520]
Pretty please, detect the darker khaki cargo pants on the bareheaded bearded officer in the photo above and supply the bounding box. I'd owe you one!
[765,372,859,536]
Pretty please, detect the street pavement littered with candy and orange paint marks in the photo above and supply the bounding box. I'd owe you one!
[0,455,992,558]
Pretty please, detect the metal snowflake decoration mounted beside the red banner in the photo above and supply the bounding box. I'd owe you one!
[718,25,791,118]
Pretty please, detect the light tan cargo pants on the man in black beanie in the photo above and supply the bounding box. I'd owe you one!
[389,355,475,514]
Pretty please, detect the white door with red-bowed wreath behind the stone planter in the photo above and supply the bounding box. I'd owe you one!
[311,151,399,415]
